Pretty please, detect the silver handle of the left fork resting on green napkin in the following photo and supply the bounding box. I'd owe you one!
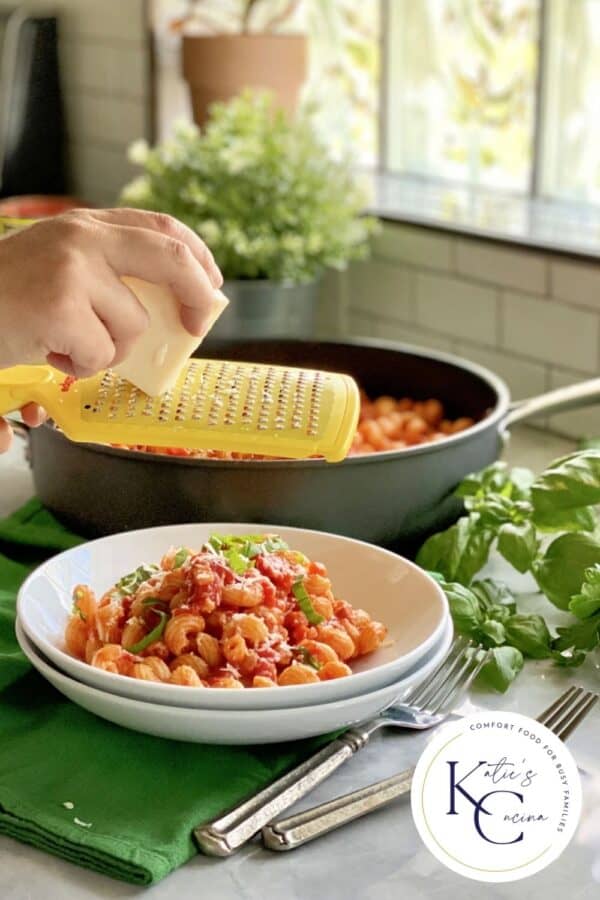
[193,728,369,856]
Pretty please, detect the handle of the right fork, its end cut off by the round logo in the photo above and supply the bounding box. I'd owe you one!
[262,768,415,850]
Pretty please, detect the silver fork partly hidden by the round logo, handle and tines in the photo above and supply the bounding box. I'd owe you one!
[262,687,598,850]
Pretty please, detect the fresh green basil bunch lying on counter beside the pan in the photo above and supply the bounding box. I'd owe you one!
[417,449,600,691]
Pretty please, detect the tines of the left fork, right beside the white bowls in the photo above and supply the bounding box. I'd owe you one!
[401,637,489,714]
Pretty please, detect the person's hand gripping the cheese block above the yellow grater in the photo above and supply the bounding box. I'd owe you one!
[0,209,223,451]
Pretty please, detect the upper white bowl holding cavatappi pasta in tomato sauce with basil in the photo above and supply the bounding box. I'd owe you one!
[17,523,449,710]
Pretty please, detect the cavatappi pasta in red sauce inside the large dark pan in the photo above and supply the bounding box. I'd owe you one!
[114,391,475,459]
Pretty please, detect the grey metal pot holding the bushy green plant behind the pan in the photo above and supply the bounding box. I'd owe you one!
[210,279,321,344]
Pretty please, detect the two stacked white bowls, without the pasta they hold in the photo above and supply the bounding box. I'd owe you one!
[17,523,452,744]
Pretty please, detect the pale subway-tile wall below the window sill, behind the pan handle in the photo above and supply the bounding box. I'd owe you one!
[321,224,600,438]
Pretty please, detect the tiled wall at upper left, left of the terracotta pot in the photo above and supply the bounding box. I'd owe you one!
[0,0,150,205]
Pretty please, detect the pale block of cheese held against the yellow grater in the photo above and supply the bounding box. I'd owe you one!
[115,276,229,397]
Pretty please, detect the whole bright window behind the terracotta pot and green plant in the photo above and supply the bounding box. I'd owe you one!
[153,0,600,204]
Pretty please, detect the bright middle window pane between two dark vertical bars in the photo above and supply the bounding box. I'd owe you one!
[385,0,539,191]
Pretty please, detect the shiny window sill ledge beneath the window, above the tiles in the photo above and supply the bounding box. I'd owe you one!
[367,173,600,260]
